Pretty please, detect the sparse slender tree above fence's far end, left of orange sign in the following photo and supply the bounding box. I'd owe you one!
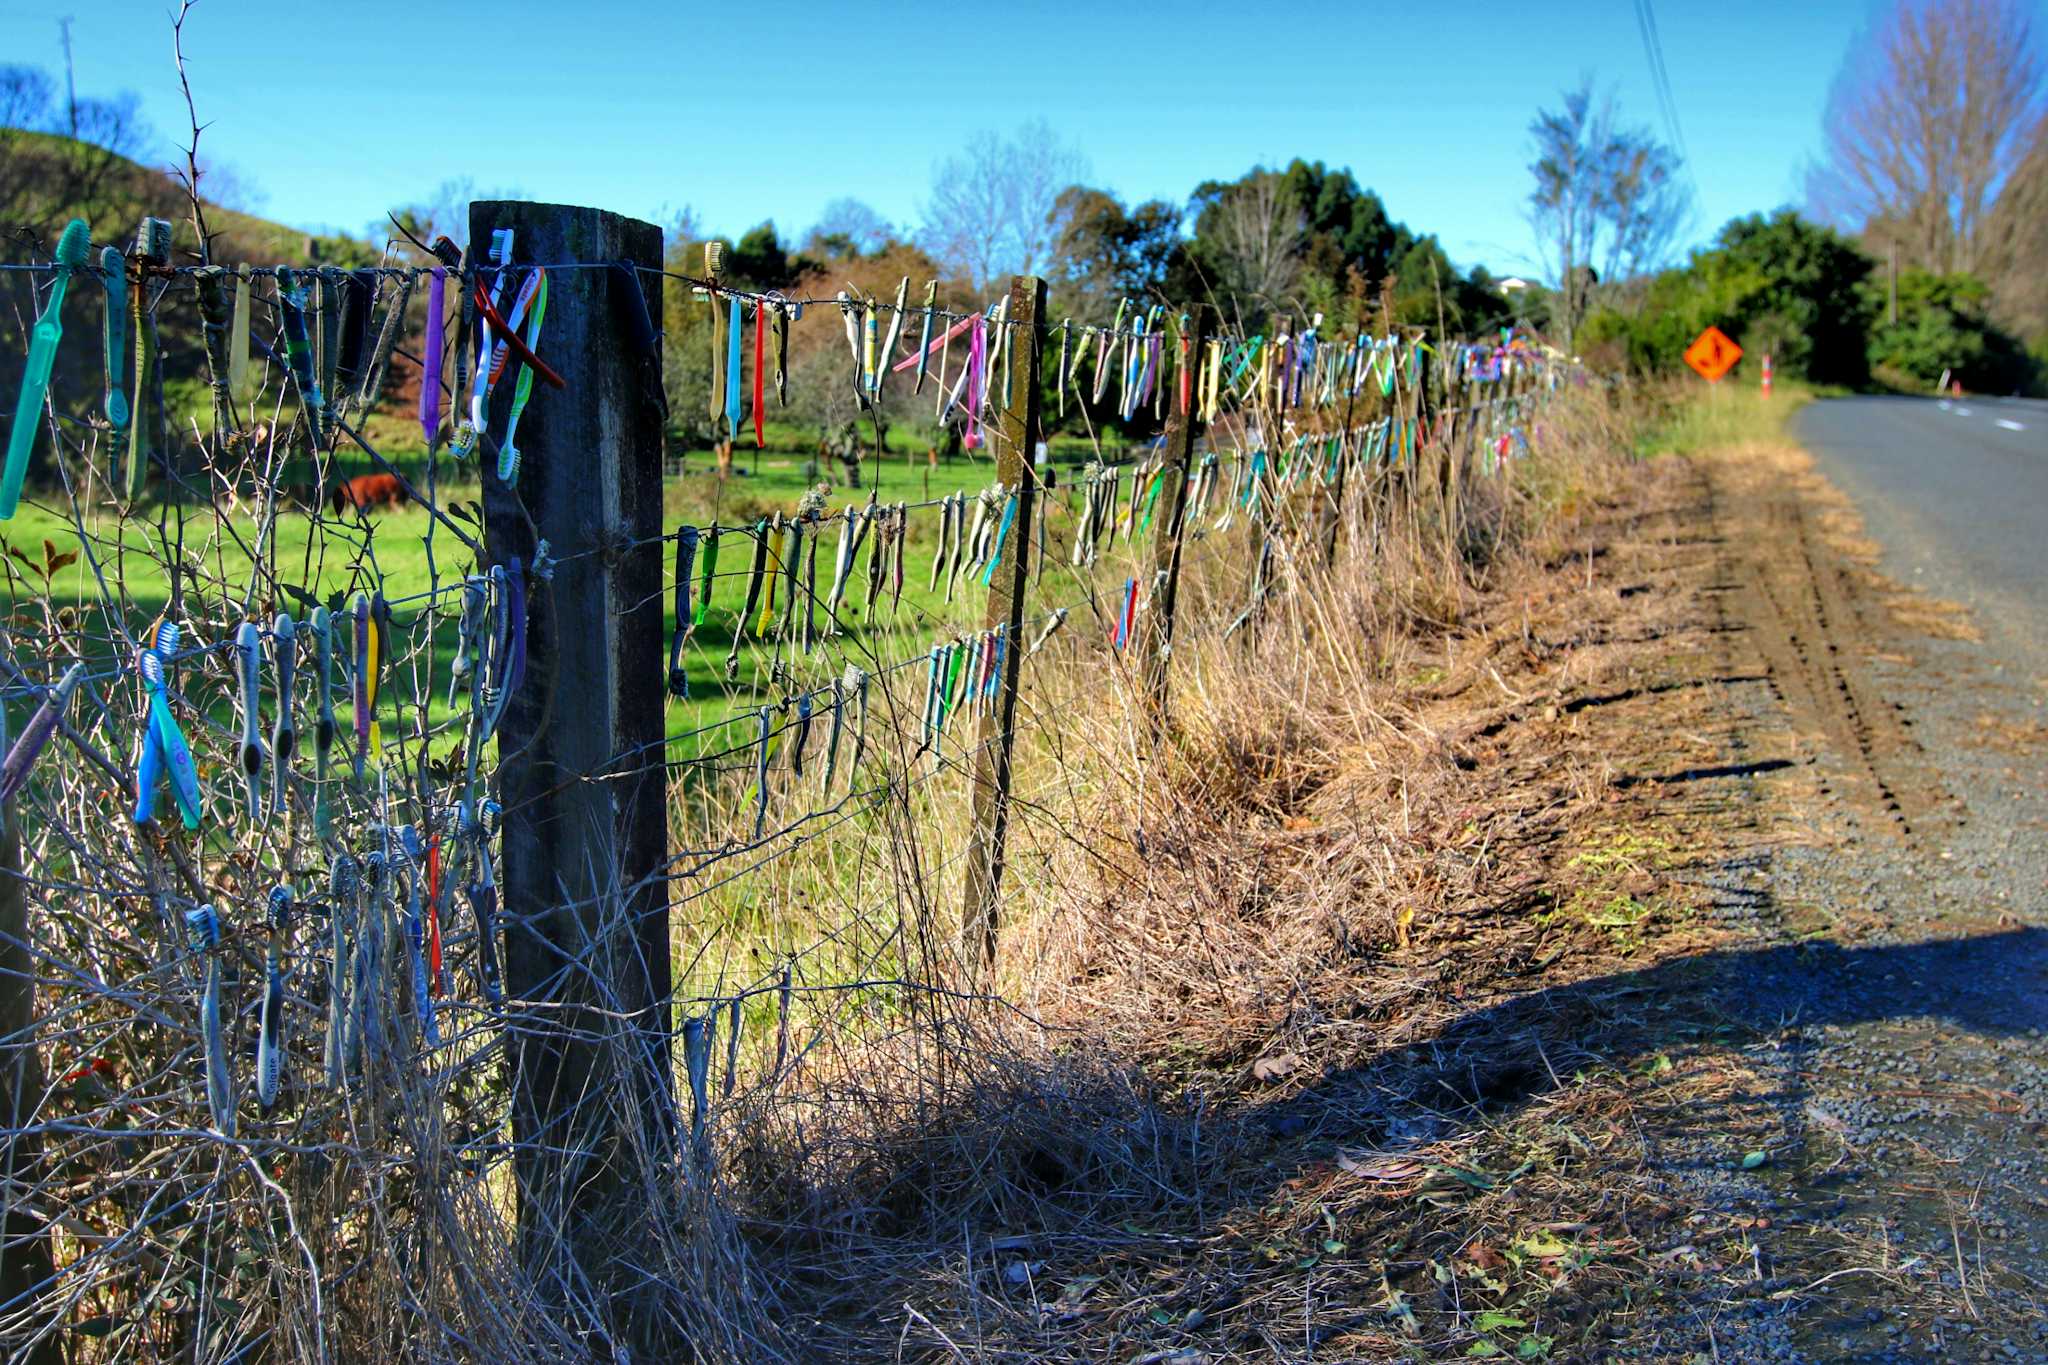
[1528,78,1692,350]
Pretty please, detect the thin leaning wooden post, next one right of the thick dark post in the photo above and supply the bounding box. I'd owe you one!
[961,274,1044,970]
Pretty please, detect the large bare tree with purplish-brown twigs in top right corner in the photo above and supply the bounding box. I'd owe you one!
[1806,0,2042,274]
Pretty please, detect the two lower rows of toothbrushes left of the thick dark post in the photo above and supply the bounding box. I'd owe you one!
[0,563,524,1136]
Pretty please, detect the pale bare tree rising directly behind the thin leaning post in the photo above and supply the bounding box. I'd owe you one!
[922,121,1087,289]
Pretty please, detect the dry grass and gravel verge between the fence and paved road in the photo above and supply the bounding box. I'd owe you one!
[827,431,2048,1365]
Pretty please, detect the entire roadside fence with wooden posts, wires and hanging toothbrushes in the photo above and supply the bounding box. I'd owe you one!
[0,205,1571,1359]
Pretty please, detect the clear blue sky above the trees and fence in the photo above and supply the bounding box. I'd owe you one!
[0,0,1882,274]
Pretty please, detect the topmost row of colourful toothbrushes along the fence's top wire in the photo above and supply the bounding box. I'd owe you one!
[0,219,1544,520]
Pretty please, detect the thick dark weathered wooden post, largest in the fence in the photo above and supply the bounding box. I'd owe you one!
[469,201,678,1355]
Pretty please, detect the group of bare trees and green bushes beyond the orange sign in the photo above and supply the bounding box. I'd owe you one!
[1528,0,2048,393]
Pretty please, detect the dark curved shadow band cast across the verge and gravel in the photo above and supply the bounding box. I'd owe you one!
[1247,929,2048,1144]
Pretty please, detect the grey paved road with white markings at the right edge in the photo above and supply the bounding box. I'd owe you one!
[1794,397,2048,686]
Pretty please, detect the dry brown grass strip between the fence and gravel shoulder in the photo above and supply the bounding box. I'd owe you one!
[638,378,1777,1361]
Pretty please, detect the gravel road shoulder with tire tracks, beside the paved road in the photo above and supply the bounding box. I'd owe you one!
[1692,448,2048,1361]
